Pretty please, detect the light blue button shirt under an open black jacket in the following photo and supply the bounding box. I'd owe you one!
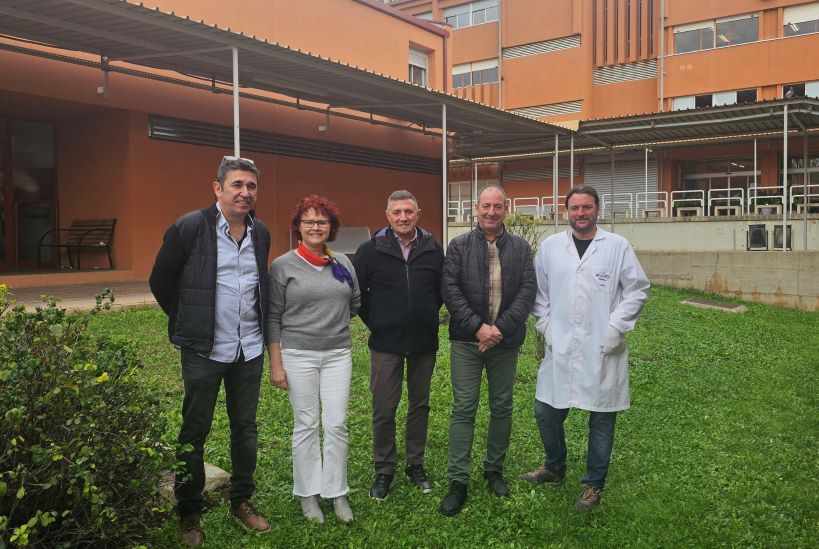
[208,202,264,362]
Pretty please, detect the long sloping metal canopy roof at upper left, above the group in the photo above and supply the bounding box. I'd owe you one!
[0,0,570,154]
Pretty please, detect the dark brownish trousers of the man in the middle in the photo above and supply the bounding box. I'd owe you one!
[370,349,435,475]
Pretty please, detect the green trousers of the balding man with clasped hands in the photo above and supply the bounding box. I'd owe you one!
[449,341,520,484]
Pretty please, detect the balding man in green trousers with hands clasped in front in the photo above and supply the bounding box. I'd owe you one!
[439,185,537,516]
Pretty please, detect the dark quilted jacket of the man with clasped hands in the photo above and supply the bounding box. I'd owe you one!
[442,227,537,347]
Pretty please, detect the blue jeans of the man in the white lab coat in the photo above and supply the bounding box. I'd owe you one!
[535,399,617,488]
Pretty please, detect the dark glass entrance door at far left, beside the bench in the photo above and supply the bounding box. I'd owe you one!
[0,118,57,271]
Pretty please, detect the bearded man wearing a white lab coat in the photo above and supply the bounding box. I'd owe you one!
[521,186,649,510]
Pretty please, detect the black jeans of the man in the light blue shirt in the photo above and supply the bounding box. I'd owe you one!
[174,350,264,516]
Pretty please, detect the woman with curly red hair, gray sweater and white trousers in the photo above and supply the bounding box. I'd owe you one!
[267,195,361,522]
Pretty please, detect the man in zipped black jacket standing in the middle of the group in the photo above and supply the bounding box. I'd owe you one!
[353,191,444,499]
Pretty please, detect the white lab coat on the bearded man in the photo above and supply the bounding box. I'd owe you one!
[534,227,649,412]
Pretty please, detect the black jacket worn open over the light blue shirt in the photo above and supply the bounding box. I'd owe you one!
[149,203,270,355]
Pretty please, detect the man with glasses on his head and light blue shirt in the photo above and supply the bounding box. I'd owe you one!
[150,156,270,547]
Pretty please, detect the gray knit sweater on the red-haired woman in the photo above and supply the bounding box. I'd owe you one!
[267,250,361,351]
